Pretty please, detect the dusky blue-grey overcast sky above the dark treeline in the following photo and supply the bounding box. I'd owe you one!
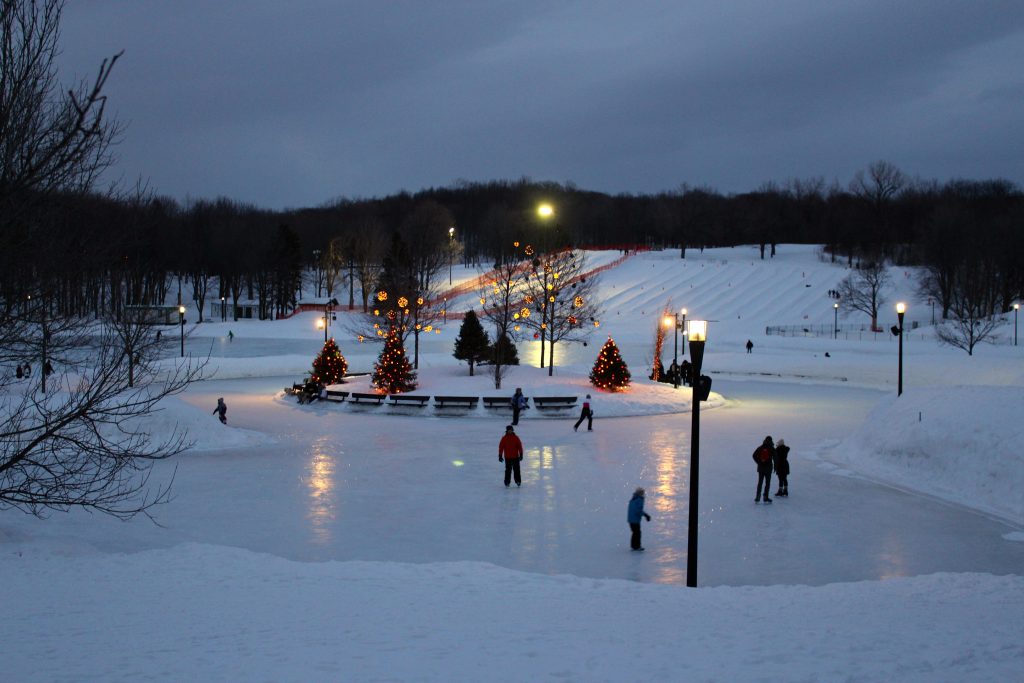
[61,0,1024,208]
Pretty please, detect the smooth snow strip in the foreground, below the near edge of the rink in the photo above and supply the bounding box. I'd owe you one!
[0,544,1024,683]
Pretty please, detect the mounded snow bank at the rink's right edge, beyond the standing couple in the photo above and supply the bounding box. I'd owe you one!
[828,386,1024,524]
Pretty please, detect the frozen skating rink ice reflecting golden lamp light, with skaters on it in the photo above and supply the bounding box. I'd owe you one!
[18,379,1024,586]
